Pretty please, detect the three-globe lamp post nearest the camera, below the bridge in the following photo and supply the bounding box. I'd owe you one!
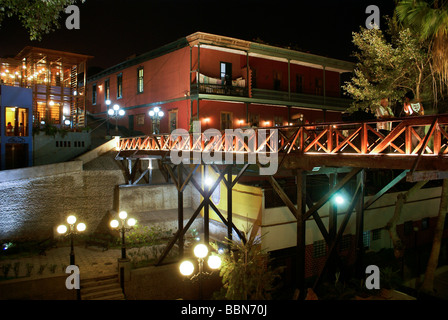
[179,243,221,299]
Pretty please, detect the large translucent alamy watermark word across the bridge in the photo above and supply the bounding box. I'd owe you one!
[170,121,278,175]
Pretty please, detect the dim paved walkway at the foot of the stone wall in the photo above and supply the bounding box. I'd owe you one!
[0,246,121,279]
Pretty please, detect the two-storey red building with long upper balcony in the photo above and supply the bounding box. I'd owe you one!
[86,32,353,134]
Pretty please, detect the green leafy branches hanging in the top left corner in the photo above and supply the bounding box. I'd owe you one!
[0,0,85,40]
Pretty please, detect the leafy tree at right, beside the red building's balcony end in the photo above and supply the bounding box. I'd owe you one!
[343,20,432,112]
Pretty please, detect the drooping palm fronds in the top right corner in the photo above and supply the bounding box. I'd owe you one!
[395,0,448,84]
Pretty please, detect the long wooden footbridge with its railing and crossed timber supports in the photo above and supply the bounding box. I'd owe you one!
[116,114,448,298]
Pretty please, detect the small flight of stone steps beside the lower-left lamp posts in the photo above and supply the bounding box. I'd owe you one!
[81,274,125,300]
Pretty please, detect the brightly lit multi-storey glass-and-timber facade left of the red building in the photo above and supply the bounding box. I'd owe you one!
[0,46,92,128]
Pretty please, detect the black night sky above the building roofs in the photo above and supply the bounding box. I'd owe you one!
[0,0,394,73]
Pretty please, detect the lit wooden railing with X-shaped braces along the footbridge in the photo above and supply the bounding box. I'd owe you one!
[117,114,448,155]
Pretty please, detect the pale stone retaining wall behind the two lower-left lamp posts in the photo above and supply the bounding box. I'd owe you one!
[0,162,124,239]
